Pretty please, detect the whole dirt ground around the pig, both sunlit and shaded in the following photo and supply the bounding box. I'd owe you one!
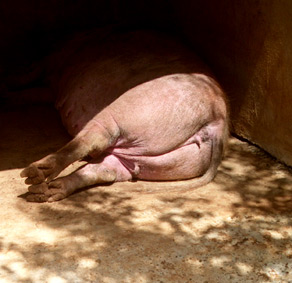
[0,105,292,283]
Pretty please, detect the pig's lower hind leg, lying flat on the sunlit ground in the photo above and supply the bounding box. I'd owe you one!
[27,155,132,202]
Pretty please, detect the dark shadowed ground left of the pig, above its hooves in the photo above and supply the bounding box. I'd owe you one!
[0,104,70,171]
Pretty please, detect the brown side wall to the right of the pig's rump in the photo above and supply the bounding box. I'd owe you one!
[175,0,292,165]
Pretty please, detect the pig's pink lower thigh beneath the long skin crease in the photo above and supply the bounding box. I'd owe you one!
[106,142,211,180]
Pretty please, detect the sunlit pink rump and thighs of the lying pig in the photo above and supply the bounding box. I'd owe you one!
[82,74,224,180]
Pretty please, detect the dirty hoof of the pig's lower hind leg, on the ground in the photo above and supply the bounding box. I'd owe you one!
[26,180,70,202]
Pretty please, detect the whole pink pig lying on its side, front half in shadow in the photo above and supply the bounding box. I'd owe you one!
[21,31,228,201]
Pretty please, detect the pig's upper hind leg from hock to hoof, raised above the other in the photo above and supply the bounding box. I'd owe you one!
[20,120,115,185]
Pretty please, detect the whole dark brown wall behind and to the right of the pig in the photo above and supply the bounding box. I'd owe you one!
[0,0,292,165]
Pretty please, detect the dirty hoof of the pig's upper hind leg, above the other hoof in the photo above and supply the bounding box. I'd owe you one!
[20,155,62,185]
